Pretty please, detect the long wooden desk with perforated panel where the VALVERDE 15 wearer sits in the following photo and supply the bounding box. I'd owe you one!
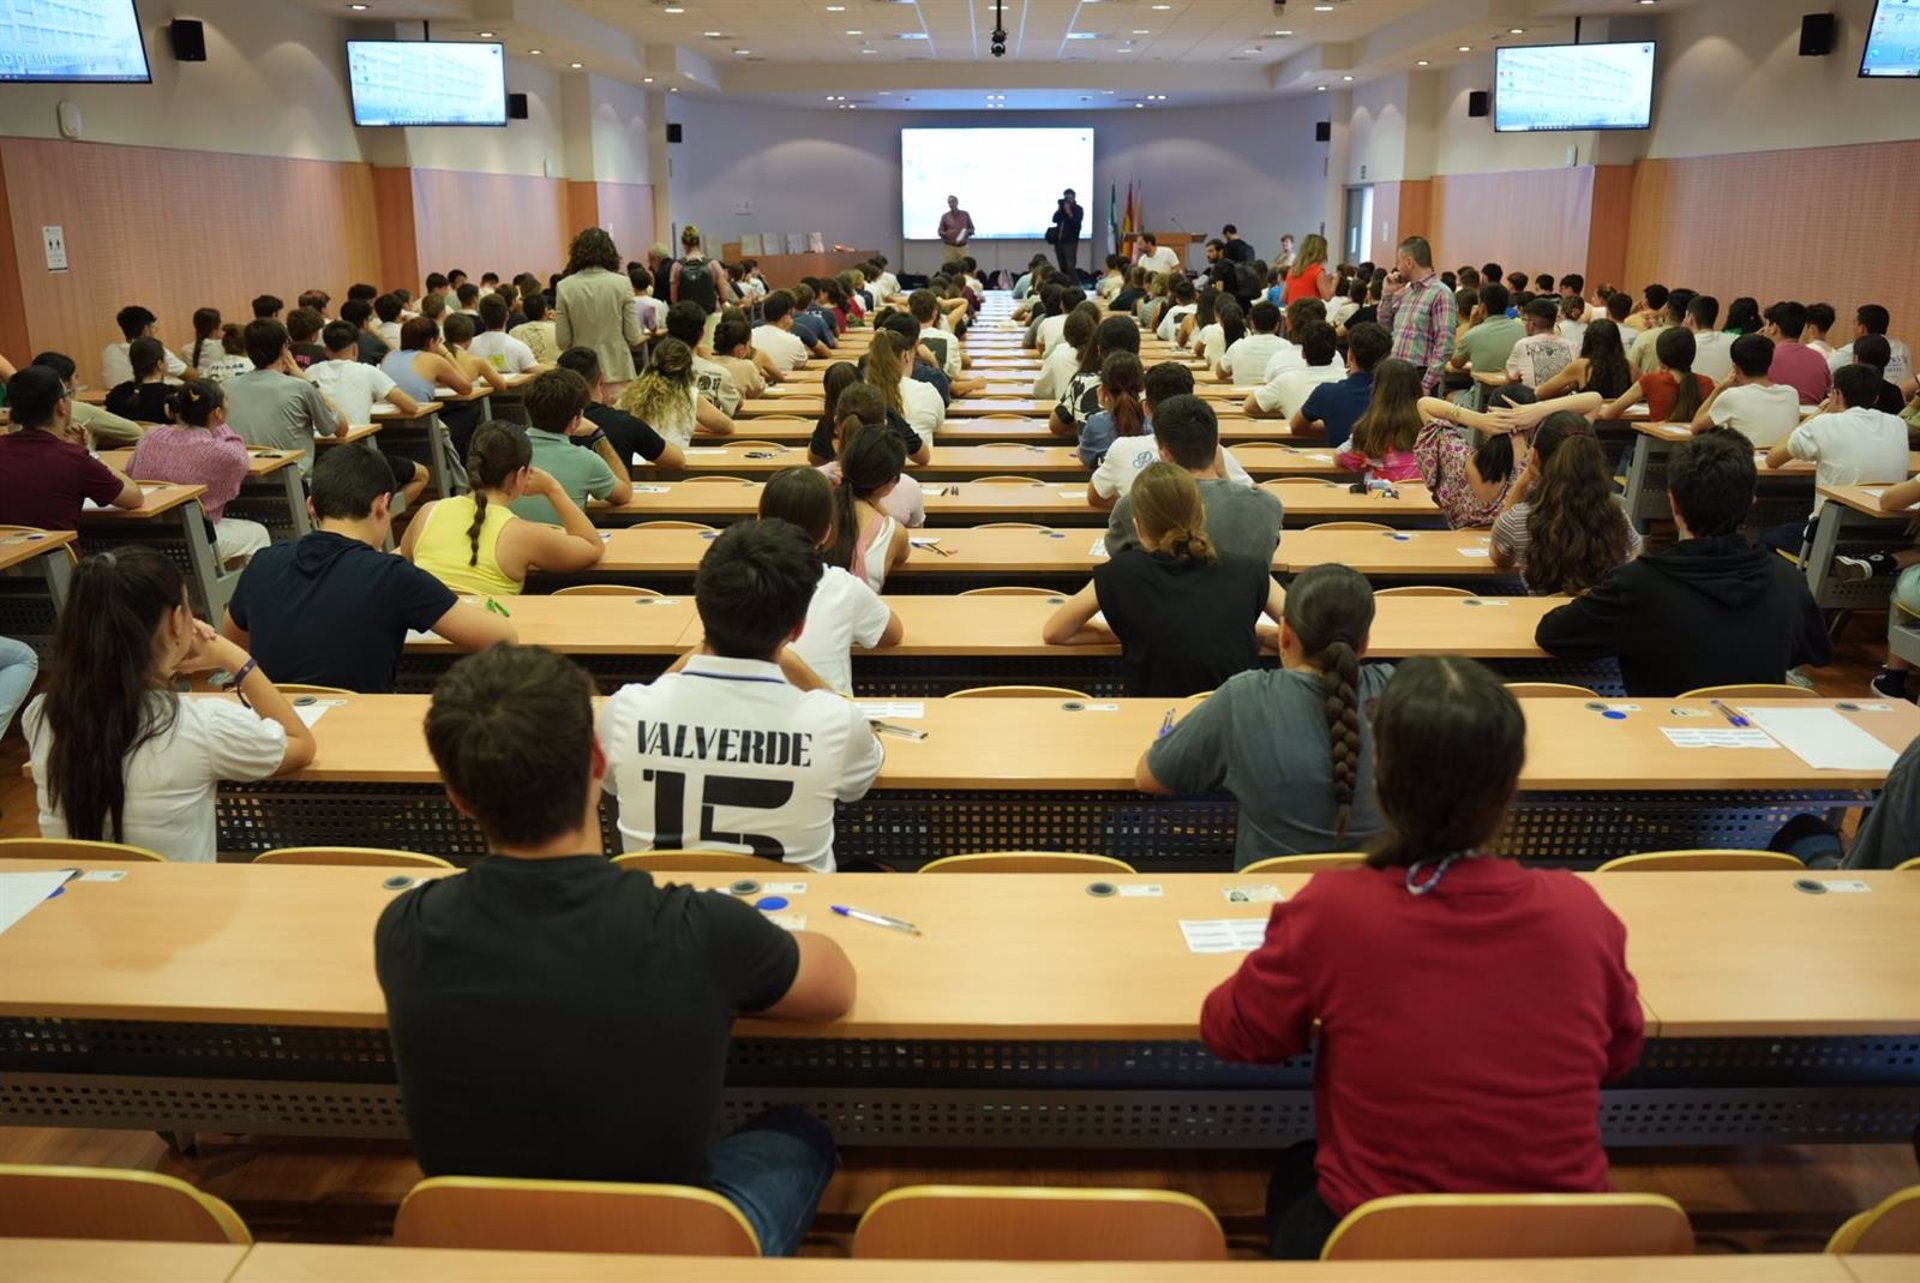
[198,695,1920,870]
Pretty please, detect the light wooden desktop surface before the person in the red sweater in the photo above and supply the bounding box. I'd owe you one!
[0,860,1920,1041]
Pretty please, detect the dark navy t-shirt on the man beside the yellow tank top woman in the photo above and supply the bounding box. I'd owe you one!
[227,530,459,695]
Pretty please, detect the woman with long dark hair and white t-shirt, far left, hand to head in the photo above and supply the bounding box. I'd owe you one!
[23,545,313,862]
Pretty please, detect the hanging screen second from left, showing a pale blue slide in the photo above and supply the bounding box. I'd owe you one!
[348,40,507,125]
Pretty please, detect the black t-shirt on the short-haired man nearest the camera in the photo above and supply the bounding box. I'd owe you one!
[374,855,801,1185]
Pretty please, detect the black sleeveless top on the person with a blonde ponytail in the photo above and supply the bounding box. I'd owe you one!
[1092,547,1271,699]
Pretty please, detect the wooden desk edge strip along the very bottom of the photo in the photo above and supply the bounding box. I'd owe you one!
[0,1239,1889,1283]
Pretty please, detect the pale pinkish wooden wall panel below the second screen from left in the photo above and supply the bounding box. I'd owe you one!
[413,169,572,280]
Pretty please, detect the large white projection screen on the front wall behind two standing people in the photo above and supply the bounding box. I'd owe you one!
[900,129,1106,240]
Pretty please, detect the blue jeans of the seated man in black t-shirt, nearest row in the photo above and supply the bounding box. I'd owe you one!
[712,1104,835,1256]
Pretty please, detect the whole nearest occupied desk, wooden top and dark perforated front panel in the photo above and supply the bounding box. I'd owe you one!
[0,860,1920,1149]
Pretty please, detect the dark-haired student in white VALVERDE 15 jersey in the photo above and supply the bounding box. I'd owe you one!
[599,522,885,872]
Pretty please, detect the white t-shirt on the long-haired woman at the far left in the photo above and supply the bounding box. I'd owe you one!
[21,691,286,864]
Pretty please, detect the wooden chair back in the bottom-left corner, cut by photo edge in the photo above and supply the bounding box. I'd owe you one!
[0,1162,253,1245]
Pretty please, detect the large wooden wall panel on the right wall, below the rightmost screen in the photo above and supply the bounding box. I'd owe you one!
[1624,140,1920,346]
